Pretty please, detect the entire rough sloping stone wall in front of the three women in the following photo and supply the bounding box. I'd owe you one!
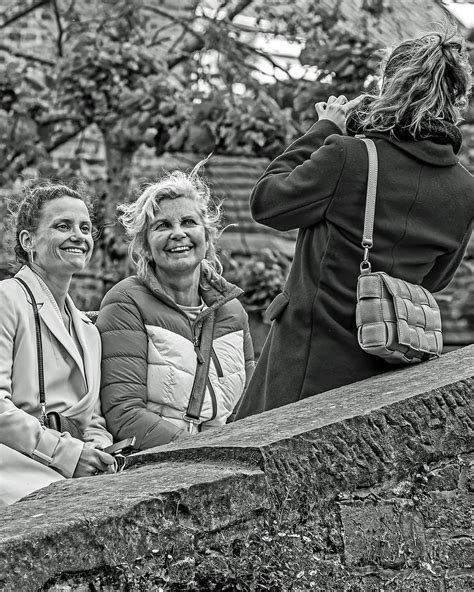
[0,346,474,592]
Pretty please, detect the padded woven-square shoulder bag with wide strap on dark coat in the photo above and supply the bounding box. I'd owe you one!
[356,138,443,364]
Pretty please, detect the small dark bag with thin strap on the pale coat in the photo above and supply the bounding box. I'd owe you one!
[15,278,83,440]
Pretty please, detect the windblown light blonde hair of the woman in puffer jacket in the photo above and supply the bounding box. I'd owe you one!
[117,159,222,279]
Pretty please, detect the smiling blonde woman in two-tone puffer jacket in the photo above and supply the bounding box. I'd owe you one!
[97,165,254,450]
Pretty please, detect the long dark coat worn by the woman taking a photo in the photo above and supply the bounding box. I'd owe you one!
[236,120,474,419]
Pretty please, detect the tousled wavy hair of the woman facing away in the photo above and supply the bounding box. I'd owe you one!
[357,26,472,138]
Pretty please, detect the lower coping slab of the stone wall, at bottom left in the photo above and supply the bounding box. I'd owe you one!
[0,463,268,592]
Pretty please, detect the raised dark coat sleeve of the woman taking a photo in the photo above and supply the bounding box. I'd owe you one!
[250,120,345,230]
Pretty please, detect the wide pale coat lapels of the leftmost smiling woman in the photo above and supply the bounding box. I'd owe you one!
[16,266,93,390]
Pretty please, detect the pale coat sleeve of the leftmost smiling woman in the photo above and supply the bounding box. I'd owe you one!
[0,289,84,478]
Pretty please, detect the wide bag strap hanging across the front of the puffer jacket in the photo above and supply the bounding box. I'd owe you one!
[183,311,215,431]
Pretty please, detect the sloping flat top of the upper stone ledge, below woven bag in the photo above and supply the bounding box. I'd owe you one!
[129,345,474,466]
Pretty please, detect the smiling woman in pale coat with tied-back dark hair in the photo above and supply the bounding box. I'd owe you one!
[0,181,114,505]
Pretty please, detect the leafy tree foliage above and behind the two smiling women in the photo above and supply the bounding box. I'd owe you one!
[0,0,392,187]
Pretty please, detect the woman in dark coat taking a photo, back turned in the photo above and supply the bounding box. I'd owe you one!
[236,26,474,418]
